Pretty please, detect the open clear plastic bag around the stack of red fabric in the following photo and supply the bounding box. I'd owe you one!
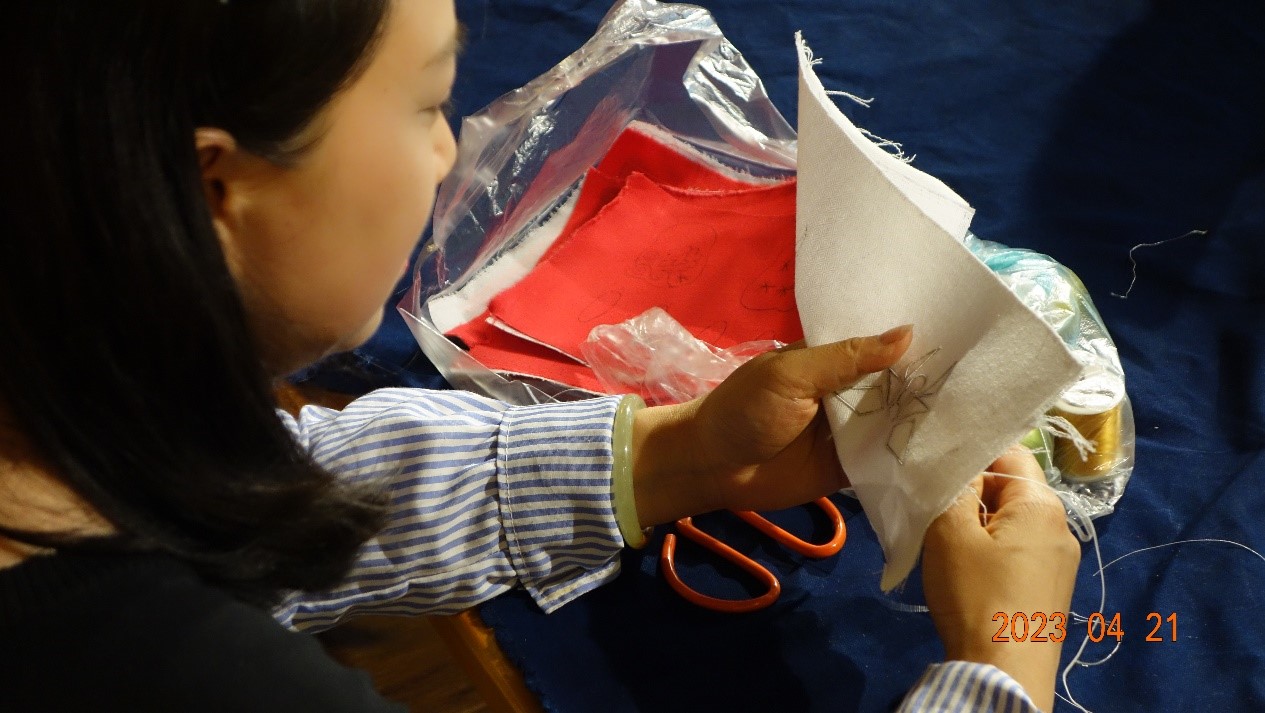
[400,0,796,403]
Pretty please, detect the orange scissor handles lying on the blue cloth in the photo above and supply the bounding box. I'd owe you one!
[659,498,848,614]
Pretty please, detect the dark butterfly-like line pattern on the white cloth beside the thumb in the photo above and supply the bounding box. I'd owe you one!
[835,346,958,465]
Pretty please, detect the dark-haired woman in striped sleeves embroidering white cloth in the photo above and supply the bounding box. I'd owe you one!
[0,0,1078,710]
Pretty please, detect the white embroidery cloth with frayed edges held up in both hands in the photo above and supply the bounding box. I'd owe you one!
[796,35,1080,590]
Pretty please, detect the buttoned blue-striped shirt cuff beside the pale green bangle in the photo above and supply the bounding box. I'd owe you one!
[497,397,624,613]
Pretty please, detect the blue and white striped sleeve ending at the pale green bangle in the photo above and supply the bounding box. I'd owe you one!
[273,388,624,631]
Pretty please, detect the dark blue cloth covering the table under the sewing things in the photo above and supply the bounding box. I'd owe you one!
[307,0,1265,712]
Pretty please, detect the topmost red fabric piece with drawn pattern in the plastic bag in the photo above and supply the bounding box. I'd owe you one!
[490,170,802,359]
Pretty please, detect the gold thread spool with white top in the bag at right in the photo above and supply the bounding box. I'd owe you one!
[1051,370,1125,483]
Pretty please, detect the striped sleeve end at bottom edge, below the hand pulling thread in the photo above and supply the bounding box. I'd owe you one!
[897,661,1041,713]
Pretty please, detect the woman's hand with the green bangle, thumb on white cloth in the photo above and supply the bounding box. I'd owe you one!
[633,326,913,526]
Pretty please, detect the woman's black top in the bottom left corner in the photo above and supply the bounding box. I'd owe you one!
[0,554,404,713]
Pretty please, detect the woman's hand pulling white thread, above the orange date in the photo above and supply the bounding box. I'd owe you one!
[922,446,1080,710]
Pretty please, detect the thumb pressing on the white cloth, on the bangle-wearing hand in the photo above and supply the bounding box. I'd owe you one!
[769,325,913,398]
